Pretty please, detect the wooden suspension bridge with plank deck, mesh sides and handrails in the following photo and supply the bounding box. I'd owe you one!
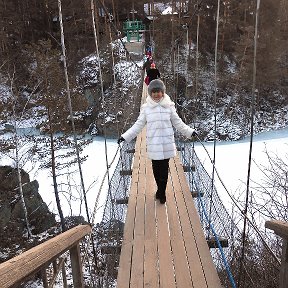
[0,1,288,288]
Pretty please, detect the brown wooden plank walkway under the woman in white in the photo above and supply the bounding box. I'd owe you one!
[117,130,222,288]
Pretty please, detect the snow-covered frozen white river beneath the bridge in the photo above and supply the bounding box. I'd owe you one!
[0,128,288,221]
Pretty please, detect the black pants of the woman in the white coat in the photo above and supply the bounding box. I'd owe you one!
[152,159,169,198]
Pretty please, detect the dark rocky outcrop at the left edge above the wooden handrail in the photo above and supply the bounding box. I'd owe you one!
[0,166,56,262]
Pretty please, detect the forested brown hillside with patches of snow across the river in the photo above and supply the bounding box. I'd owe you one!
[0,0,288,139]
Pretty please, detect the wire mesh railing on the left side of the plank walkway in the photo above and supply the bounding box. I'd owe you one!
[93,141,135,288]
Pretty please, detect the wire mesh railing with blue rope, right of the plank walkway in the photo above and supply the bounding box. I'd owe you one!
[178,142,280,288]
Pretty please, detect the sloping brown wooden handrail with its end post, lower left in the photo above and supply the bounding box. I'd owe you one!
[0,225,91,288]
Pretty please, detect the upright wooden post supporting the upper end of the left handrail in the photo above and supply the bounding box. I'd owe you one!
[70,243,84,288]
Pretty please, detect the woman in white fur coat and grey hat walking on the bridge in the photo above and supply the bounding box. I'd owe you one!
[117,79,197,204]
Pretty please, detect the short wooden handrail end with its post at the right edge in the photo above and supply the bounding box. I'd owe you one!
[265,220,288,288]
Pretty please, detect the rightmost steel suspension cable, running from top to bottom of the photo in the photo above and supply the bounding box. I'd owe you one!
[238,0,260,287]
